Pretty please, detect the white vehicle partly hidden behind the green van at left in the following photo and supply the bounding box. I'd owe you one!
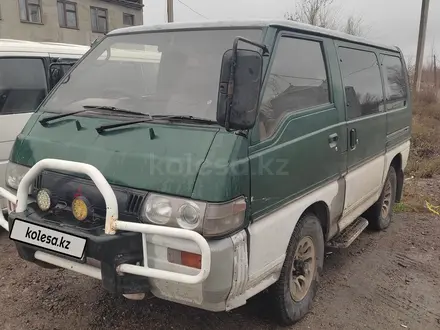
[0,39,90,209]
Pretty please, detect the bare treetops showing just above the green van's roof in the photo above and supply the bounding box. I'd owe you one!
[285,0,364,36]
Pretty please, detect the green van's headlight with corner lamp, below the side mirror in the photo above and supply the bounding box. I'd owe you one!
[141,194,246,237]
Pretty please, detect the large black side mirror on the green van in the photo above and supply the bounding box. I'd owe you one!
[217,37,266,131]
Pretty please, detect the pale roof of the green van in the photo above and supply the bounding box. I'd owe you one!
[108,19,400,51]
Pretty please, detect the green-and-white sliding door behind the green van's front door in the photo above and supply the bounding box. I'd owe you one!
[338,43,386,215]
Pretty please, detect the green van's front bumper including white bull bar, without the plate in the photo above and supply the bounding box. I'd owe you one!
[0,159,244,310]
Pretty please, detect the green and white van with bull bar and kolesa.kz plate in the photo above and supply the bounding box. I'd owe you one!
[1,21,411,325]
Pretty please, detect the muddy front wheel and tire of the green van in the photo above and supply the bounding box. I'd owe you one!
[270,214,324,326]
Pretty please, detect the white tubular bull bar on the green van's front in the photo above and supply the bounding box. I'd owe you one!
[0,159,211,284]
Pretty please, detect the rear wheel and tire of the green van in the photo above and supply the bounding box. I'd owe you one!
[364,166,397,230]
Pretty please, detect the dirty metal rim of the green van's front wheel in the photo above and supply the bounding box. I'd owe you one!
[289,236,316,302]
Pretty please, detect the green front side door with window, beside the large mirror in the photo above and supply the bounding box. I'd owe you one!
[250,33,346,219]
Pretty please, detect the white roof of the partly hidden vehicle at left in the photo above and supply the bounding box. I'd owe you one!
[0,39,90,55]
